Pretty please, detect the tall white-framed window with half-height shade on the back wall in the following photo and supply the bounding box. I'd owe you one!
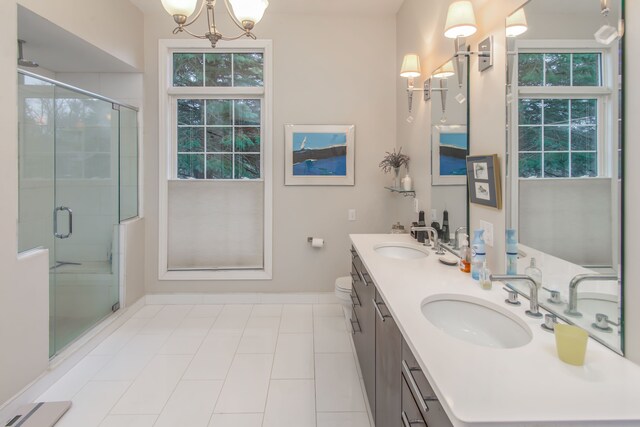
[159,40,272,280]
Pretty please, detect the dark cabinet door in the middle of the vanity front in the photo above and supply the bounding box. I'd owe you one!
[374,293,402,427]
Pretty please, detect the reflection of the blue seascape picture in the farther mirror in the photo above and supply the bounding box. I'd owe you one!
[431,125,469,185]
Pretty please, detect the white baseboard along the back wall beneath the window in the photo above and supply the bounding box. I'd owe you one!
[145,292,340,305]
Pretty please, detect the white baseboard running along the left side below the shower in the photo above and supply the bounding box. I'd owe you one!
[0,298,145,422]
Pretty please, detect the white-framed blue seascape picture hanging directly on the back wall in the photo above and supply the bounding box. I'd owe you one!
[284,124,355,185]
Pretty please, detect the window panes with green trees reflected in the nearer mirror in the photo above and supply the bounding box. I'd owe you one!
[518,51,605,178]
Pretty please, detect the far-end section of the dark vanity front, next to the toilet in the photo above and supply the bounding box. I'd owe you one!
[351,248,376,414]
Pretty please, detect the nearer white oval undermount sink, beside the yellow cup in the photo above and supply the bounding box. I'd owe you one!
[422,295,533,348]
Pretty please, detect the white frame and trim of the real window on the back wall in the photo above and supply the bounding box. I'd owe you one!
[158,39,273,280]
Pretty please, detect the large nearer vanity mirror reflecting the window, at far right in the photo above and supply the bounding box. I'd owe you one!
[506,0,623,354]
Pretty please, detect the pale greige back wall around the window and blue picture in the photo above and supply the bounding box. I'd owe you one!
[144,12,397,293]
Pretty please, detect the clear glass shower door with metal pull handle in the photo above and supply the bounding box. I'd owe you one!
[51,86,119,354]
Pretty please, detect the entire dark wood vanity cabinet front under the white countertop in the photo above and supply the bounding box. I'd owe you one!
[351,248,452,427]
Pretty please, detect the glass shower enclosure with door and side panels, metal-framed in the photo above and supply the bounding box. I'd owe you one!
[18,70,138,356]
